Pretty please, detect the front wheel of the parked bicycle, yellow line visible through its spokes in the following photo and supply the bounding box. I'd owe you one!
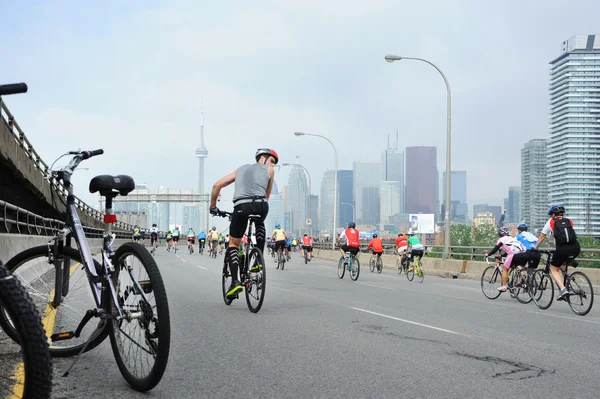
[0,245,110,357]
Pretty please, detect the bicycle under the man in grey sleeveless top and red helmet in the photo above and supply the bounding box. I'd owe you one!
[215,211,267,313]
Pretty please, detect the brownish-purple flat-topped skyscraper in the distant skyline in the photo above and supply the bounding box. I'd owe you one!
[405,146,438,216]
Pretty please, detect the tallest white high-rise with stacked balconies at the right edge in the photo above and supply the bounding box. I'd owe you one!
[544,35,600,236]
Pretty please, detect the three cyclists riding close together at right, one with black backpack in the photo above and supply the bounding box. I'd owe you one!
[484,205,581,301]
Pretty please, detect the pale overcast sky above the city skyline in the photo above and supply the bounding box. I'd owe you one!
[0,0,600,228]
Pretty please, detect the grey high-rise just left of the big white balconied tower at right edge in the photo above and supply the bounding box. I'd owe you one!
[519,139,549,234]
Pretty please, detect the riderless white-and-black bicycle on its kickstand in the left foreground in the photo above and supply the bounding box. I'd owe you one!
[0,150,171,391]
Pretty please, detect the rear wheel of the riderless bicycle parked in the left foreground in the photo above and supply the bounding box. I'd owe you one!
[110,243,171,392]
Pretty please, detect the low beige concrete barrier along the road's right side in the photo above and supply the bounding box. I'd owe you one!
[313,249,600,293]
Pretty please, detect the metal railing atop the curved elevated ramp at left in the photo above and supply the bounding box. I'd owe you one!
[0,97,133,230]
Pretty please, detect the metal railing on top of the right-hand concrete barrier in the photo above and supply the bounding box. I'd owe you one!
[313,242,600,267]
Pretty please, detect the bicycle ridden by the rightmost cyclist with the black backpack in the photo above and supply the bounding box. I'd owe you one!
[531,250,594,316]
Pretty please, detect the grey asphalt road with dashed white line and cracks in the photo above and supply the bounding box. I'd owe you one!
[44,248,600,398]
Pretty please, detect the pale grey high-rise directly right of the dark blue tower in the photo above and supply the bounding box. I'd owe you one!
[353,161,381,225]
